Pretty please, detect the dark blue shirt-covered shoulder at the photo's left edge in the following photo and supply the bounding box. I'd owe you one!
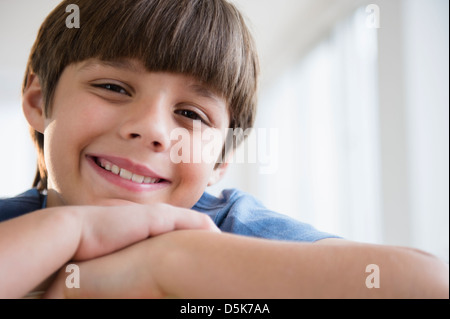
[0,188,45,222]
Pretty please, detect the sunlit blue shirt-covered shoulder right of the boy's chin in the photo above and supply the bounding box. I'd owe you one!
[193,189,337,242]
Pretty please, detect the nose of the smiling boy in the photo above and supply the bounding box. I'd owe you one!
[119,100,171,152]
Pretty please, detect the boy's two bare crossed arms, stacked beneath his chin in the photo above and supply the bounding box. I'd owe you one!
[0,206,449,298]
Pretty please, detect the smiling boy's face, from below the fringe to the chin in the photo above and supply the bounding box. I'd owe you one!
[37,60,229,208]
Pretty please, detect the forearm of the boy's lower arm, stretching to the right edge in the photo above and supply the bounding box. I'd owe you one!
[154,232,448,298]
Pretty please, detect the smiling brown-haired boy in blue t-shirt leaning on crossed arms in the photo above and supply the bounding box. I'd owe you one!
[0,0,448,298]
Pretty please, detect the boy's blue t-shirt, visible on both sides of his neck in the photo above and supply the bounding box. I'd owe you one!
[0,189,337,242]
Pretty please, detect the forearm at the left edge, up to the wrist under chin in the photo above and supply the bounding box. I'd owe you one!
[0,207,80,298]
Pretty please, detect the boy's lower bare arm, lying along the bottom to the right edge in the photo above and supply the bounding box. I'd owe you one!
[47,231,448,298]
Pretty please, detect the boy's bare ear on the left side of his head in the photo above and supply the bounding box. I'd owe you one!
[22,72,45,133]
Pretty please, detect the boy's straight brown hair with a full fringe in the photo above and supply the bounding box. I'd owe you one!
[23,0,259,189]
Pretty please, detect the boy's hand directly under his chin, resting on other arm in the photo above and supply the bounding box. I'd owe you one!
[73,204,220,260]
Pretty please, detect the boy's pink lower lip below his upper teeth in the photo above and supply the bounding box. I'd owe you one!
[86,156,170,192]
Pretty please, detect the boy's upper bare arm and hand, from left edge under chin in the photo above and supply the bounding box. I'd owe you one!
[0,204,218,298]
